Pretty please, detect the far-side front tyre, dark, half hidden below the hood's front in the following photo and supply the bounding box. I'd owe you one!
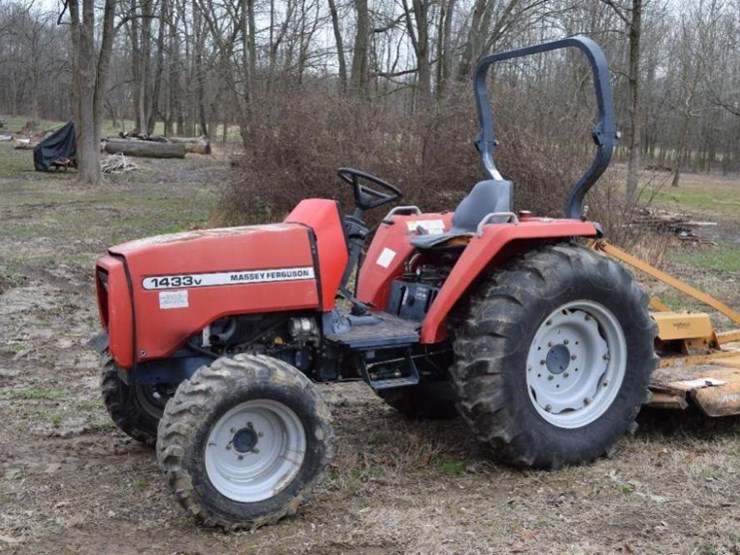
[100,358,172,445]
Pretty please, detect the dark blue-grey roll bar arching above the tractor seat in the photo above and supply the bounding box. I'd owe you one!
[473,36,619,219]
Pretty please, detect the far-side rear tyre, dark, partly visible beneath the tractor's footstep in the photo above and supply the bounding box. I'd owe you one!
[376,381,457,420]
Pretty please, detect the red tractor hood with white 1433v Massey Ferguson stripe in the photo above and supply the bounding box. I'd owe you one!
[97,224,321,368]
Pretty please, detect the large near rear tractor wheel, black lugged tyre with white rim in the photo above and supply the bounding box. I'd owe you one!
[451,245,657,469]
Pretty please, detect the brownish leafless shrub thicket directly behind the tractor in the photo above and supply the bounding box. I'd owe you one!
[219,82,652,254]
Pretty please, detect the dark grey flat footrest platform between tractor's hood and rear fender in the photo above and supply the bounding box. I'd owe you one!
[325,312,419,349]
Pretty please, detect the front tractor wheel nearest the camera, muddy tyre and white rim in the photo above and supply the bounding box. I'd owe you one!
[157,354,334,530]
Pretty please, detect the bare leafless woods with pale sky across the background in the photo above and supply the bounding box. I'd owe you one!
[0,0,740,191]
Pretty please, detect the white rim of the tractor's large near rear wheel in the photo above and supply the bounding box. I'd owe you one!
[527,301,627,429]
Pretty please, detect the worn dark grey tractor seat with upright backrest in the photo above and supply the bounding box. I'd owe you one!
[411,179,514,249]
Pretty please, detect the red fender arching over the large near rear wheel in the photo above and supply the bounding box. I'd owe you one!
[421,218,600,343]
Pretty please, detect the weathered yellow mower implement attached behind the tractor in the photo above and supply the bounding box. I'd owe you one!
[589,239,740,416]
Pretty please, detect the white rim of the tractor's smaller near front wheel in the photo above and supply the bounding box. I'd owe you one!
[205,399,306,503]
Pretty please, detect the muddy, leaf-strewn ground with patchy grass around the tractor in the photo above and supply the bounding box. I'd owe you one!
[0,149,740,555]
